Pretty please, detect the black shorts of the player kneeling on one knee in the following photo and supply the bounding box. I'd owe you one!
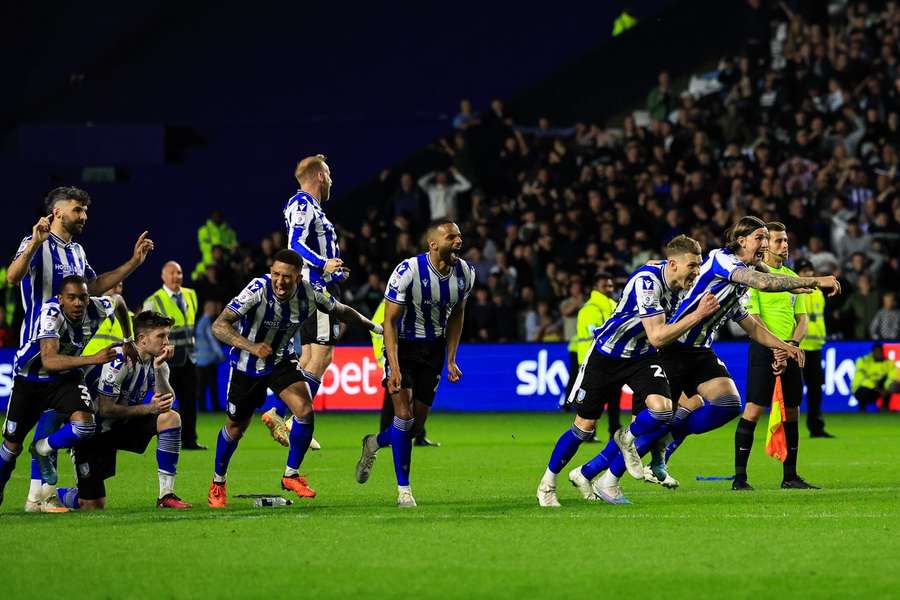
[73,415,157,500]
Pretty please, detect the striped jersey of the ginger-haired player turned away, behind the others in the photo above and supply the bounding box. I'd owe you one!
[284,191,343,287]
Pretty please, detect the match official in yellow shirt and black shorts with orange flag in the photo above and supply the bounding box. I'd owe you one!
[731,221,817,490]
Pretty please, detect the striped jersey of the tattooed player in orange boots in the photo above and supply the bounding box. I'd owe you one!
[228,275,337,377]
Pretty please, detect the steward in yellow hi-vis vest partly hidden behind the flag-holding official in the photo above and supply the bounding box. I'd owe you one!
[794,258,834,438]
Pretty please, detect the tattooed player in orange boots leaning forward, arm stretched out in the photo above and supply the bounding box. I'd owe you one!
[207,249,381,508]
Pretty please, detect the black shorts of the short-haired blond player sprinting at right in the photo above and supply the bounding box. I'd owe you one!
[569,350,671,420]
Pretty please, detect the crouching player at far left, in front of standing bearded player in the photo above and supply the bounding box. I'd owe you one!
[0,275,123,512]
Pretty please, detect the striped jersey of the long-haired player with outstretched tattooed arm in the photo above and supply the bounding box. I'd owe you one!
[669,248,749,348]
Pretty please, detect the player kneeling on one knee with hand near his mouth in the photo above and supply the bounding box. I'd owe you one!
[58,310,191,510]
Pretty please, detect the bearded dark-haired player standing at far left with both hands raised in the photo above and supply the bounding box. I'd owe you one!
[7,187,153,509]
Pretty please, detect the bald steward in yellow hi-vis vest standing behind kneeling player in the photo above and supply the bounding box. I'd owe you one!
[144,260,206,450]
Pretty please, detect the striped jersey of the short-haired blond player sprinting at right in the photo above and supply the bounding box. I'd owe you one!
[594,262,678,358]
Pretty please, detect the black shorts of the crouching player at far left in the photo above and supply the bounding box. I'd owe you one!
[3,370,94,444]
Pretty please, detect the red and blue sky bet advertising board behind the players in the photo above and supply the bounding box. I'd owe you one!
[0,342,900,412]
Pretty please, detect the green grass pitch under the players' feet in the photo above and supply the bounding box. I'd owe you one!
[0,413,900,599]
